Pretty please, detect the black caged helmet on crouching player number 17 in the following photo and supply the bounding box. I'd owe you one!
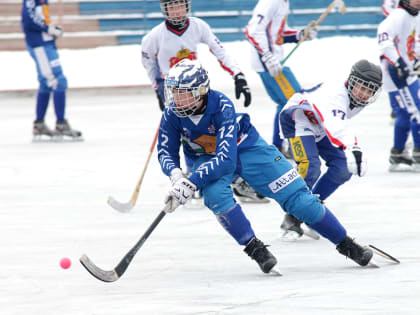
[347,59,382,106]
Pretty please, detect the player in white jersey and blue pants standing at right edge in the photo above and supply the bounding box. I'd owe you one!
[378,0,420,171]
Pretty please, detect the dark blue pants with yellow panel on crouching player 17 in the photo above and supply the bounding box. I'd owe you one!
[289,136,352,200]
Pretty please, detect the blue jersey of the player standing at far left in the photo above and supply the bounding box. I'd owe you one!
[22,0,54,47]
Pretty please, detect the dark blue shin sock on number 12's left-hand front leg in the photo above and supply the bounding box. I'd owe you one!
[216,204,255,245]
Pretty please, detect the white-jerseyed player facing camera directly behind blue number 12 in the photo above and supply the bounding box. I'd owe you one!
[142,0,268,203]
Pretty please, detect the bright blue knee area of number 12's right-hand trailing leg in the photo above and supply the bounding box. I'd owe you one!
[283,187,324,224]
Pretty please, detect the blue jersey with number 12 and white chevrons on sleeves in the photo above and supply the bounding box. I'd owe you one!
[157,90,259,188]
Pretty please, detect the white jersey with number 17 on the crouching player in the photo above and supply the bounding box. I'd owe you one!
[280,81,363,150]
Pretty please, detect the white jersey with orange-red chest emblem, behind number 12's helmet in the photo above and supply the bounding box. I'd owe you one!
[142,17,241,88]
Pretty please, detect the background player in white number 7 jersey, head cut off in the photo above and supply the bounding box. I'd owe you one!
[246,0,317,156]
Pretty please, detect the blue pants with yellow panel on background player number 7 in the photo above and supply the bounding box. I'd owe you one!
[258,67,301,148]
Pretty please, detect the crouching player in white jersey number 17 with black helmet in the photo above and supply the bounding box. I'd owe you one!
[279,60,382,237]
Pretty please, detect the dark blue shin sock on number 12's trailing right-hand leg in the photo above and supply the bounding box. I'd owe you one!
[309,206,347,245]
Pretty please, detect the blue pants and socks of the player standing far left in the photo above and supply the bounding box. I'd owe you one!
[27,43,67,121]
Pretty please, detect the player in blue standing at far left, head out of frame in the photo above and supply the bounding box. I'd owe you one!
[22,0,82,139]
